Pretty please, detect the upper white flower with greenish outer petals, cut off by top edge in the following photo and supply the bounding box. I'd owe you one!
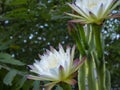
[66,0,120,24]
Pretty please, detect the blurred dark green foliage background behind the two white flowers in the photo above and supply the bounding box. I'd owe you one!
[0,0,120,90]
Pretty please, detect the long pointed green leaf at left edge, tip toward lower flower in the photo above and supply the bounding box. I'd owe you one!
[0,53,25,66]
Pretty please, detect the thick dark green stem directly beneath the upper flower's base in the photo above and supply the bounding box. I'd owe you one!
[92,24,106,90]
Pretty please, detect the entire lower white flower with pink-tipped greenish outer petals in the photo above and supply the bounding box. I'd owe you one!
[27,45,85,90]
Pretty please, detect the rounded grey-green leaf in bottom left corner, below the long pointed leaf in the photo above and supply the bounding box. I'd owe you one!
[3,69,17,86]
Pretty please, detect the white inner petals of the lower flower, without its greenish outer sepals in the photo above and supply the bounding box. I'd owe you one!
[30,45,76,81]
